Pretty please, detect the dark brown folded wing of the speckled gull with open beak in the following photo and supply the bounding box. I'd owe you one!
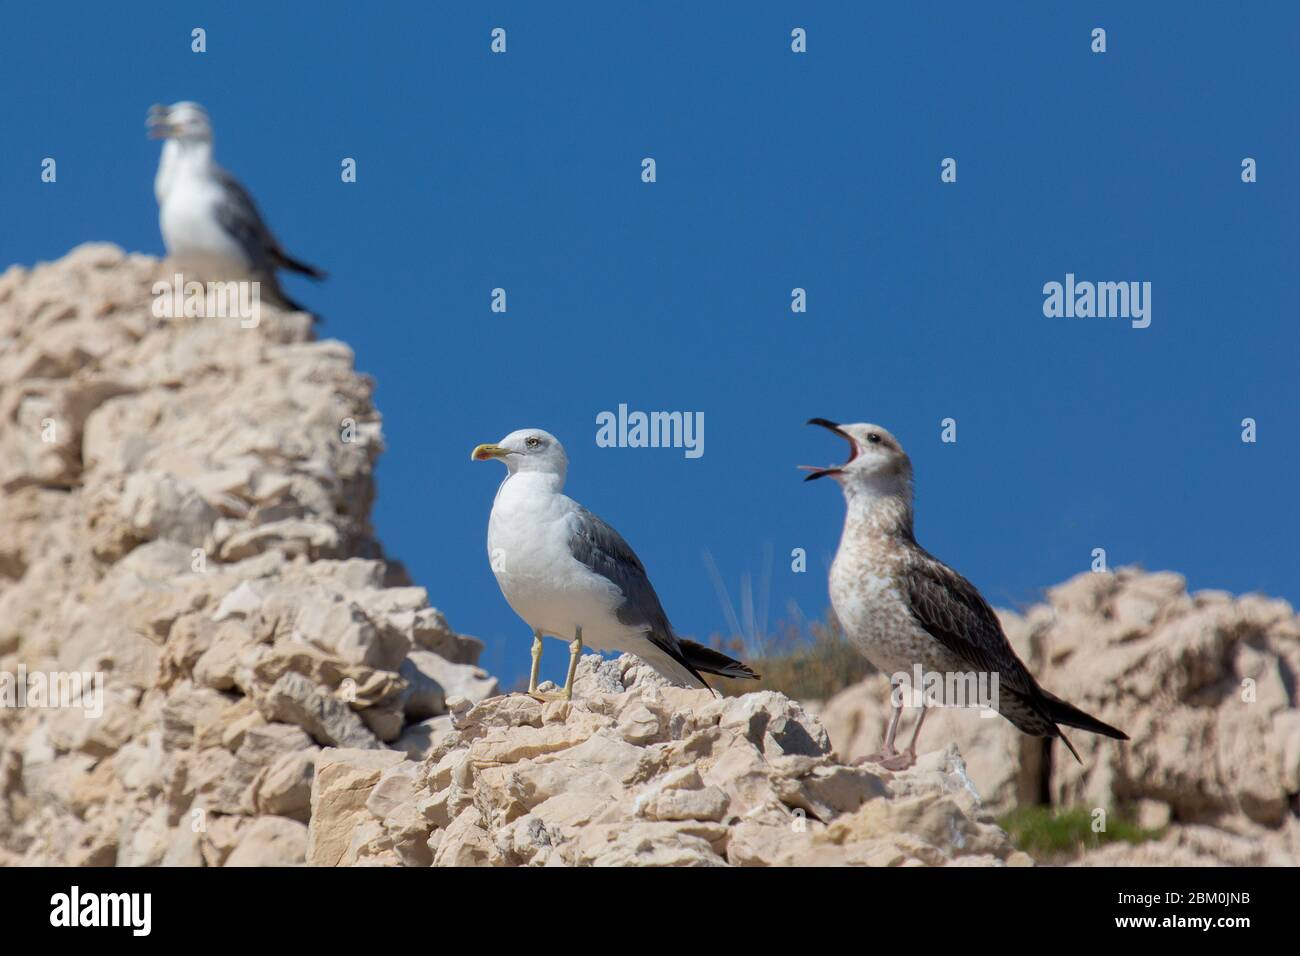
[907,554,1041,700]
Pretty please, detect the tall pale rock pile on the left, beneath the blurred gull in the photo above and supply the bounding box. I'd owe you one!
[0,246,497,865]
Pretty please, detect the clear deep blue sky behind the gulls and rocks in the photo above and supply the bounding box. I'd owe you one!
[0,3,1300,683]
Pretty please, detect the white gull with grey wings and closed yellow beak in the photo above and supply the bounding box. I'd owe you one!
[469,428,758,700]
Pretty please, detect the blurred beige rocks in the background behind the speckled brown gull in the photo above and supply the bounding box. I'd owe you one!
[820,568,1300,865]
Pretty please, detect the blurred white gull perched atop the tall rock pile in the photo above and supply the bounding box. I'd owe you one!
[147,103,325,312]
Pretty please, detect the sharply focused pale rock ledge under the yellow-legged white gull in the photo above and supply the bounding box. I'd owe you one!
[307,656,1032,866]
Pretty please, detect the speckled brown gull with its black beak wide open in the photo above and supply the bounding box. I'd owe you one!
[801,419,1128,770]
